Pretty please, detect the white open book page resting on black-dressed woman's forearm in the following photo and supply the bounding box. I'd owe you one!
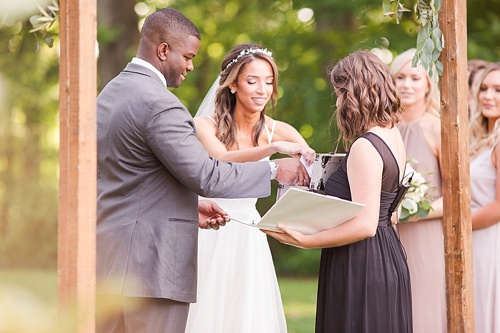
[232,188,364,234]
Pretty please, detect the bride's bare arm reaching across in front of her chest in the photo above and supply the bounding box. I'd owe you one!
[194,117,314,162]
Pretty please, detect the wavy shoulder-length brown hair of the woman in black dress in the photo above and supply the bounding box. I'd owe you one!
[329,51,403,145]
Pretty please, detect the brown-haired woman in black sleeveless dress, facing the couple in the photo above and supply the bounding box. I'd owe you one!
[264,51,412,333]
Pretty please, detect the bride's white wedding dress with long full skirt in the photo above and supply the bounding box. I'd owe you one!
[186,119,287,333]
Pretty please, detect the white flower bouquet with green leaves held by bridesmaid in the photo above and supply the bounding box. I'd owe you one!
[399,163,432,223]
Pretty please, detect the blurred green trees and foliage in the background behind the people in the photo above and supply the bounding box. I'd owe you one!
[0,0,500,275]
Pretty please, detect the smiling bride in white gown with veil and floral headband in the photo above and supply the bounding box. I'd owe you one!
[186,44,315,333]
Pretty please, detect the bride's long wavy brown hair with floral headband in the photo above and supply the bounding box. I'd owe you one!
[215,44,278,147]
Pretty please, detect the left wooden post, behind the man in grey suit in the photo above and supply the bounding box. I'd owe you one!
[58,0,97,333]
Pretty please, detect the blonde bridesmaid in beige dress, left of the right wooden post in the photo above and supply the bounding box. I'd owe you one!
[391,49,447,333]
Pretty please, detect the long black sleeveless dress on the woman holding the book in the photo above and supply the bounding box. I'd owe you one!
[316,132,412,333]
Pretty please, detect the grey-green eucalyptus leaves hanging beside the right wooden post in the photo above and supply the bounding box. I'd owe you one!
[382,0,444,77]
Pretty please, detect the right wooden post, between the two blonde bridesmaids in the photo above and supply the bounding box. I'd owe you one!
[439,0,474,333]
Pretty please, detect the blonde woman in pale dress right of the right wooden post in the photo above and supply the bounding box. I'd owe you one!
[470,63,500,333]
